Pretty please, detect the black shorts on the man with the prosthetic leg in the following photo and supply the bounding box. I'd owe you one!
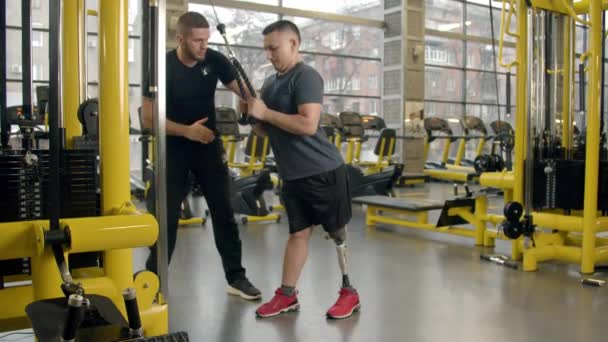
[281,165,352,234]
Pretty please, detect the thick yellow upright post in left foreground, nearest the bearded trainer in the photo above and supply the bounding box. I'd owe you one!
[99,0,133,290]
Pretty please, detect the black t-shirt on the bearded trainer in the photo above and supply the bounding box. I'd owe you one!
[144,48,236,143]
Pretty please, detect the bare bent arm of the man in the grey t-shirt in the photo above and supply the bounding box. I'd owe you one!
[248,98,321,135]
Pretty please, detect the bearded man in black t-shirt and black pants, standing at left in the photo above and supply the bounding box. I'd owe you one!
[143,12,261,300]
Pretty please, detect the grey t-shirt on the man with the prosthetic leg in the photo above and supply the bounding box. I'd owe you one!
[262,62,344,180]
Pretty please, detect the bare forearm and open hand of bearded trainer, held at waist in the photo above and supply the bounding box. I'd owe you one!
[142,96,215,144]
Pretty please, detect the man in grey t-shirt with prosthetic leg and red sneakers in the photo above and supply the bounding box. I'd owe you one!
[248,20,360,318]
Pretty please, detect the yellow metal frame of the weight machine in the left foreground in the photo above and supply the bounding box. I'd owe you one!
[0,0,169,336]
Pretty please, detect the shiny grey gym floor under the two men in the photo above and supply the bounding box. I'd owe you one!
[135,184,608,342]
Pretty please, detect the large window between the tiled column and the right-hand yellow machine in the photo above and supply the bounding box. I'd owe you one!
[425,0,516,128]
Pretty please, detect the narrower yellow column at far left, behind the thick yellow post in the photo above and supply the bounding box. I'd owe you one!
[61,0,84,148]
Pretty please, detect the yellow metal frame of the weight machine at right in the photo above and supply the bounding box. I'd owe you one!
[494,0,608,273]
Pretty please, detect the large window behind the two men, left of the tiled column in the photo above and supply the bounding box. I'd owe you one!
[189,0,382,114]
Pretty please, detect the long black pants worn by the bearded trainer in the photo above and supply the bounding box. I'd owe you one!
[146,139,245,283]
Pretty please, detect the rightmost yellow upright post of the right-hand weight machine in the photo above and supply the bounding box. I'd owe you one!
[581,1,603,273]
